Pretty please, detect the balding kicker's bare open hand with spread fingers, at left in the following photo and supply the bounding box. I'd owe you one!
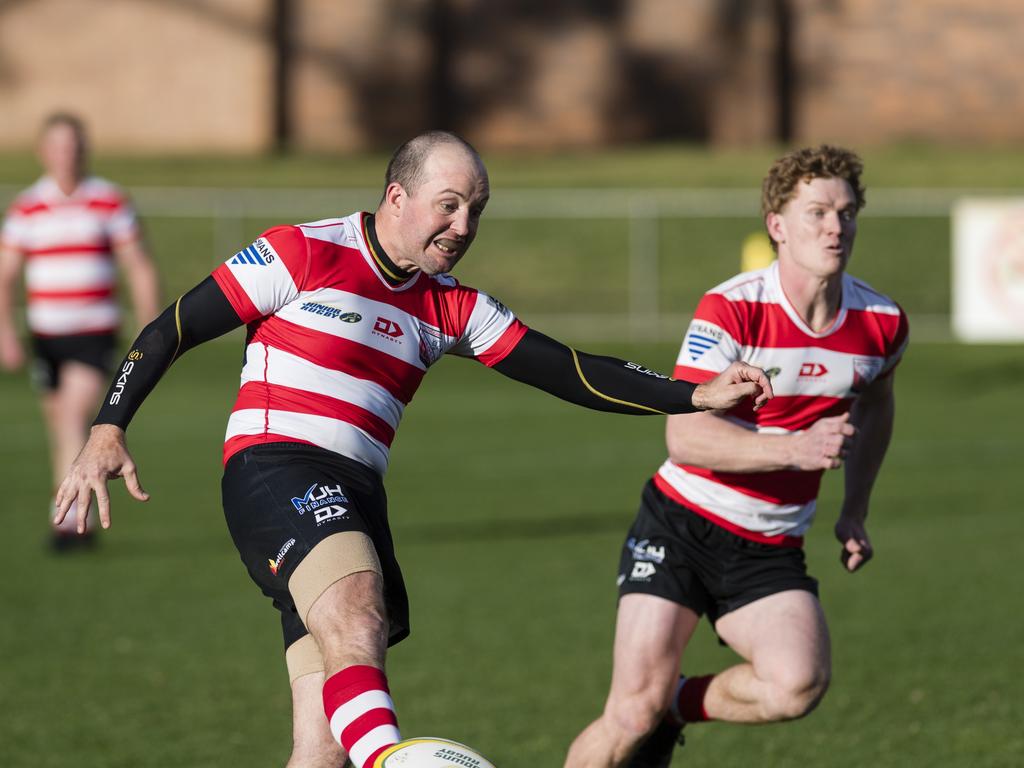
[53,424,150,534]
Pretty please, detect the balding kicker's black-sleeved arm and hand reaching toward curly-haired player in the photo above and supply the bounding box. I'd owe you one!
[494,330,772,415]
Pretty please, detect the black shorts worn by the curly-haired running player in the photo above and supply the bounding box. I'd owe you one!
[618,480,818,624]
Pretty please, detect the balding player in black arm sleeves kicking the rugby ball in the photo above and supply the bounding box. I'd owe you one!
[49,131,771,768]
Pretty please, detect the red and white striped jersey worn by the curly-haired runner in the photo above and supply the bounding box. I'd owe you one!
[654,262,908,546]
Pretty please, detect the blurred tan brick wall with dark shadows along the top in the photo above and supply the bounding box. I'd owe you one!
[0,0,1024,152]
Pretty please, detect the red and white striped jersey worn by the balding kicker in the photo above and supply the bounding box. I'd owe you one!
[213,213,526,474]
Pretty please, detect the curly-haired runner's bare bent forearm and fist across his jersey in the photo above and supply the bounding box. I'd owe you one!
[665,414,856,472]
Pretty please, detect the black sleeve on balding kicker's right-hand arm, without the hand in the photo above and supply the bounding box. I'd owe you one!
[494,331,697,415]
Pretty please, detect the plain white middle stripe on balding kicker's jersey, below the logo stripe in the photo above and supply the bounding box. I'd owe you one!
[242,342,406,429]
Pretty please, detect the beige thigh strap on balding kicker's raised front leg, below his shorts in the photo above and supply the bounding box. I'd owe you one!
[288,530,383,626]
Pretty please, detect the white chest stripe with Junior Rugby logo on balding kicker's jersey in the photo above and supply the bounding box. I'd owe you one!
[278,288,454,371]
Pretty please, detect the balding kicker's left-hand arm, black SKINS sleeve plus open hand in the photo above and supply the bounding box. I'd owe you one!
[54,278,243,532]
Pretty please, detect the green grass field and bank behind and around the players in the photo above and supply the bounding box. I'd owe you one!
[0,147,1024,768]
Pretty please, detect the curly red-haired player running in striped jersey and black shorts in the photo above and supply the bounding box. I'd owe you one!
[565,145,907,768]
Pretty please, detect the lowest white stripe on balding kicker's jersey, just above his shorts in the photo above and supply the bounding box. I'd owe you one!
[224,409,389,475]
